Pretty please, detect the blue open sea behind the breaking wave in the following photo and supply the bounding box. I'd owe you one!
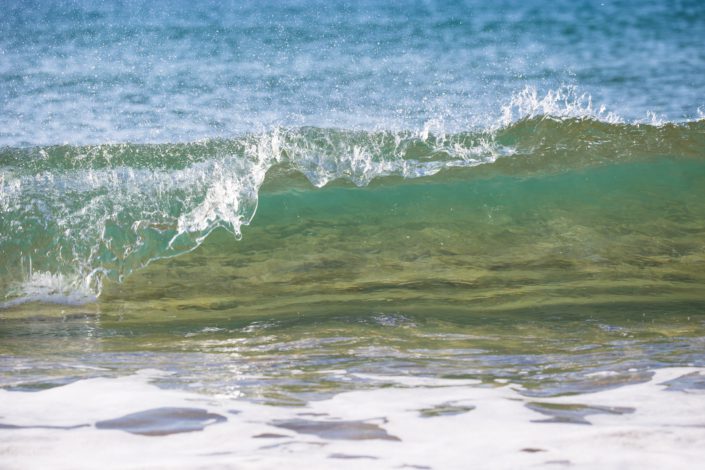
[0,0,705,147]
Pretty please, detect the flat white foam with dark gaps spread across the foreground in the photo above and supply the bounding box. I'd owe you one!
[0,368,705,469]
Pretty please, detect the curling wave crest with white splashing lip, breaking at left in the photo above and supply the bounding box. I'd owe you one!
[0,107,705,303]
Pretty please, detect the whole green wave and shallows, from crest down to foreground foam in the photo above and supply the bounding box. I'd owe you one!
[1,118,705,403]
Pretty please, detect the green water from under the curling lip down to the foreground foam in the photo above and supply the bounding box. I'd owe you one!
[0,157,705,404]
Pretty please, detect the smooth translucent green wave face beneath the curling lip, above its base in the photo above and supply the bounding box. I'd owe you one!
[102,155,705,318]
